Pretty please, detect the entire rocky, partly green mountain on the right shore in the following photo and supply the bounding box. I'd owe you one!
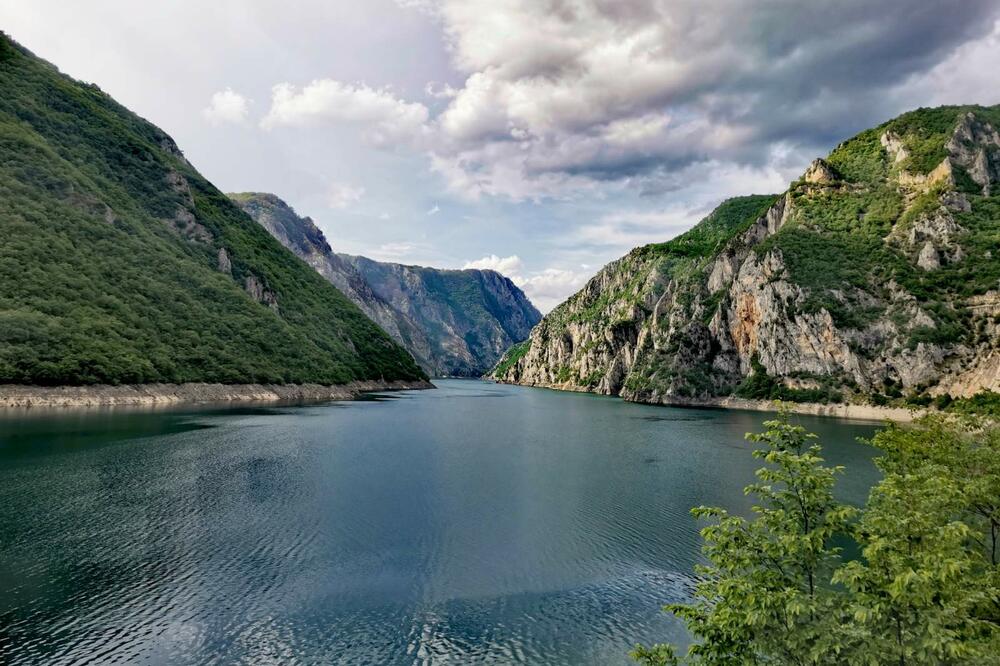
[494,106,1000,405]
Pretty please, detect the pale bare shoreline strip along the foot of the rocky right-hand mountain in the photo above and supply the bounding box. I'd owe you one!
[491,379,929,423]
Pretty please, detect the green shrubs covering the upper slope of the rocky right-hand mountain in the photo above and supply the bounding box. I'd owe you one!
[755,107,1000,340]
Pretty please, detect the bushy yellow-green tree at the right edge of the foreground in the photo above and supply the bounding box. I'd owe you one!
[833,417,1000,664]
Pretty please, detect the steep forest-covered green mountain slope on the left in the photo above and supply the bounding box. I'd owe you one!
[0,33,424,385]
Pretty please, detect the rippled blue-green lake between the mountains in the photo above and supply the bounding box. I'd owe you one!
[0,380,877,665]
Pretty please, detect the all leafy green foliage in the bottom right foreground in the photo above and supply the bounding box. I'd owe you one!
[632,412,1000,666]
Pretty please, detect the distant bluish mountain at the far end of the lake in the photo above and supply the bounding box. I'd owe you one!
[229,192,541,377]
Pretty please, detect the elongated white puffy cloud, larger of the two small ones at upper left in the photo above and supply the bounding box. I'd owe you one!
[261,79,429,146]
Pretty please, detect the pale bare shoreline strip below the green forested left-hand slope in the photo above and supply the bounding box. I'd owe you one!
[0,380,435,409]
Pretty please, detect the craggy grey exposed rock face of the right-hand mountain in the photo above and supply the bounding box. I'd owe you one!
[496,107,1000,403]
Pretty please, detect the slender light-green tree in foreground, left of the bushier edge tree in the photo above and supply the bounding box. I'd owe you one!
[632,411,854,666]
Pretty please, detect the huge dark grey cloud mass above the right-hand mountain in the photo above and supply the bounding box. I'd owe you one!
[416,0,1000,199]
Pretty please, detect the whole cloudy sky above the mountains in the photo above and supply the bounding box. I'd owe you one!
[0,0,1000,312]
